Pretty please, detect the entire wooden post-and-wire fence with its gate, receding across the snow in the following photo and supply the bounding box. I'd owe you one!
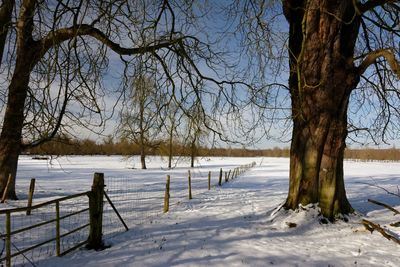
[0,162,255,266]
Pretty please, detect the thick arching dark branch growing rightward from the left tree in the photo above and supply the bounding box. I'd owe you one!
[39,24,185,58]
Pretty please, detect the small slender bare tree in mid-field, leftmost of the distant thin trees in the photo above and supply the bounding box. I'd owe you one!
[120,74,162,169]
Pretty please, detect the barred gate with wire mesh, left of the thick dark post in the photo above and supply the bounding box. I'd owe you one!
[0,194,89,266]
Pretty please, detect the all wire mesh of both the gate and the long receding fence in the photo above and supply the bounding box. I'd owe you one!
[0,163,255,266]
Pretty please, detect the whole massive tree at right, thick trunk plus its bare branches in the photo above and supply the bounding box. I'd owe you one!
[225,0,400,220]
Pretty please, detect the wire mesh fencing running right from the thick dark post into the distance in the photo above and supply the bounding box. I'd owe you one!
[103,162,255,236]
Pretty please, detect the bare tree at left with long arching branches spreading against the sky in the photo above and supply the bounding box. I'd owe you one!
[0,0,250,198]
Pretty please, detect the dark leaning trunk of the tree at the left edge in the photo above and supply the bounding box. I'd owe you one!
[0,1,36,199]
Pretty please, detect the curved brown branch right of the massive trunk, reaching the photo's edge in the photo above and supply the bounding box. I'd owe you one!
[358,49,400,79]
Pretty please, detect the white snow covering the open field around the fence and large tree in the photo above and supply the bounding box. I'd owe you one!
[4,156,400,267]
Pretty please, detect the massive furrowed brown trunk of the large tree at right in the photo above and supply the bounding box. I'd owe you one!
[284,0,359,220]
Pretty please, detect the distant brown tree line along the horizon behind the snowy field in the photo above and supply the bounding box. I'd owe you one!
[23,136,400,161]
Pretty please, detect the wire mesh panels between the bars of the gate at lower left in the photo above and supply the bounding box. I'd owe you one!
[0,196,89,266]
